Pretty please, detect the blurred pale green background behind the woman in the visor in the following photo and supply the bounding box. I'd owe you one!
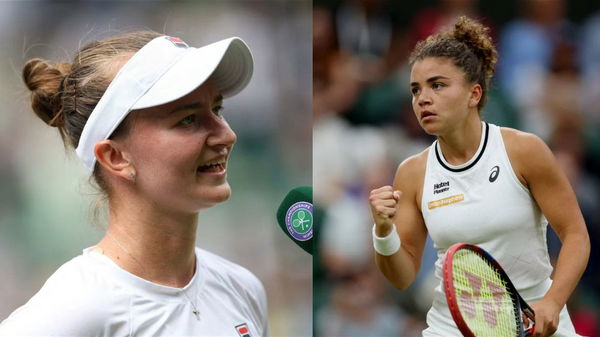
[0,0,312,336]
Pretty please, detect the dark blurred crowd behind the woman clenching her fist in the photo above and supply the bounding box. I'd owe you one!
[313,0,600,336]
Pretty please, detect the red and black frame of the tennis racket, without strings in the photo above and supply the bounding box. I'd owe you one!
[442,243,535,337]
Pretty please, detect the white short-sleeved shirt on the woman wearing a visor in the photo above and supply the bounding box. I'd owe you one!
[0,248,269,337]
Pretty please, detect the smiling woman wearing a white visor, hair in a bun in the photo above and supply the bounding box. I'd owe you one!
[0,32,268,337]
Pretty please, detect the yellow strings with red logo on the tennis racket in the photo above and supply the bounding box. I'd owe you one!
[453,250,519,337]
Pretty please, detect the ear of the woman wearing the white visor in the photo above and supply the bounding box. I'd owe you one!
[94,139,135,181]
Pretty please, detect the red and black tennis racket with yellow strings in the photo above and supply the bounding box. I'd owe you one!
[443,243,535,337]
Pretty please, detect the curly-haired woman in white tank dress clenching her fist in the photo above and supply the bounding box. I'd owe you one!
[369,17,590,337]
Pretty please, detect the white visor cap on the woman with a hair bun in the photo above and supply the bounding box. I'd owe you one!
[75,36,253,171]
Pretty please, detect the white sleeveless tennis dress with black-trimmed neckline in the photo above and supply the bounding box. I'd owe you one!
[421,123,578,337]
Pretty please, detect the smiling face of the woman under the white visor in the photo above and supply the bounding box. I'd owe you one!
[125,81,236,212]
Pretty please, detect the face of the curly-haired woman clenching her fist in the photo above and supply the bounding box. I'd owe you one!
[410,57,476,135]
